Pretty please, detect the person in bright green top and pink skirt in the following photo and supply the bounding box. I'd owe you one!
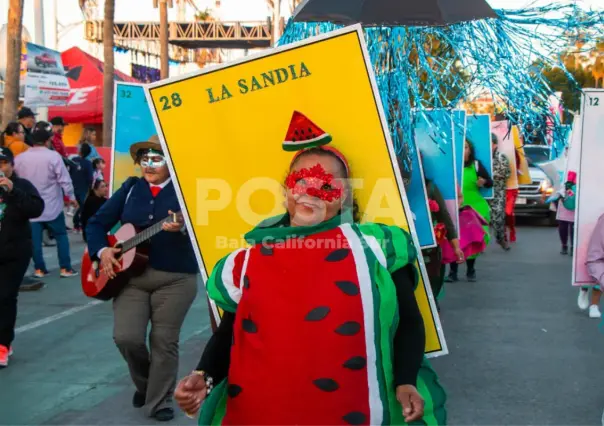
[447,140,493,282]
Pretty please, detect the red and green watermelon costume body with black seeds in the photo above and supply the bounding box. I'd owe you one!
[199,217,446,425]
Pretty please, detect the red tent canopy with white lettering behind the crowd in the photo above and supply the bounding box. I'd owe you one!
[48,47,137,124]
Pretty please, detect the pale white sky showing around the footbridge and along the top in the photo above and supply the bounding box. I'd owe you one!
[0,0,604,74]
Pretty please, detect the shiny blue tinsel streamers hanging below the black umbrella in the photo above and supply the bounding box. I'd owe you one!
[279,4,604,171]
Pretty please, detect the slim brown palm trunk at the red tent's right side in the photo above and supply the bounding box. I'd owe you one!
[103,0,115,146]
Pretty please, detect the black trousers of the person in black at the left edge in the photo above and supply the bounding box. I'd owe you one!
[0,252,31,347]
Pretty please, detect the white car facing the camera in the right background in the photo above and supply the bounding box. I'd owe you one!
[514,145,556,225]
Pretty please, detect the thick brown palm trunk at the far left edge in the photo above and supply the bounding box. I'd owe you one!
[2,0,24,129]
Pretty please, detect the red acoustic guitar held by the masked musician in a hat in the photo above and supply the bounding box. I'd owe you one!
[82,213,182,300]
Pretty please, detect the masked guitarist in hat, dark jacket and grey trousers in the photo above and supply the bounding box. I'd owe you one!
[86,136,198,421]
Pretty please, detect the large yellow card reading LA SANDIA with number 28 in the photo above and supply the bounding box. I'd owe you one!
[146,26,447,356]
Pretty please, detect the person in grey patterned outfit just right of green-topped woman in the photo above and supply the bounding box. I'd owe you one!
[489,133,512,251]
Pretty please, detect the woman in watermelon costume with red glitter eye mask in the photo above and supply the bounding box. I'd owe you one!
[175,113,446,425]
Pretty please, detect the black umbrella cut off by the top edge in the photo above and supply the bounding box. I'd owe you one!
[293,0,497,27]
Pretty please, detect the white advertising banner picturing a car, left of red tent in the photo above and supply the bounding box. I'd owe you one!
[25,43,69,108]
